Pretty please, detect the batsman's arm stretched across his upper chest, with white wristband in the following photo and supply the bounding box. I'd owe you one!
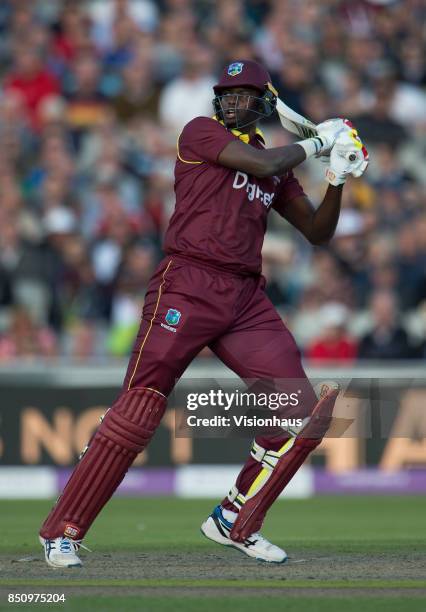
[217,136,331,178]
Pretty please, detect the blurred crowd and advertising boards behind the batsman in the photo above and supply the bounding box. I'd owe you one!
[0,0,426,497]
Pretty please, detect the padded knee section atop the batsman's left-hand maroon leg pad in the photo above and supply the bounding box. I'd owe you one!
[95,388,167,453]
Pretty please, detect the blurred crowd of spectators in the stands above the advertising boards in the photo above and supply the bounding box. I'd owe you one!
[0,0,426,364]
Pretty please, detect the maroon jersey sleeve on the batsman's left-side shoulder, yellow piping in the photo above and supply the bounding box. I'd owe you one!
[177,117,235,164]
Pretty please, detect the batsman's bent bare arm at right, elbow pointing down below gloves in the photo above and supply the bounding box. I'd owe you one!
[281,185,343,245]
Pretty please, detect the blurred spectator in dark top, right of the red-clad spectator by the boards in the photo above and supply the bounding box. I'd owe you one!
[358,290,415,360]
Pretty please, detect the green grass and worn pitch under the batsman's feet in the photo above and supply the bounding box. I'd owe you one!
[0,497,426,612]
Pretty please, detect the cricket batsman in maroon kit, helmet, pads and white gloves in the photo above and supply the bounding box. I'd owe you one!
[40,60,368,568]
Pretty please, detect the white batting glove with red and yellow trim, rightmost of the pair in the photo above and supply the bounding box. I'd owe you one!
[325,128,369,186]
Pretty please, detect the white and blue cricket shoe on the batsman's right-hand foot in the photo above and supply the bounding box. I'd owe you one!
[201,506,287,563]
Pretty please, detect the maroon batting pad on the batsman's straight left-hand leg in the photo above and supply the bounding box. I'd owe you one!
[40,388,167,540]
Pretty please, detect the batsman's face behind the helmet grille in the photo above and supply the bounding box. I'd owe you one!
[220,87,262,128]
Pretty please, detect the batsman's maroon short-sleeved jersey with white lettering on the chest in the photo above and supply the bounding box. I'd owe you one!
[164,117,304,274]
